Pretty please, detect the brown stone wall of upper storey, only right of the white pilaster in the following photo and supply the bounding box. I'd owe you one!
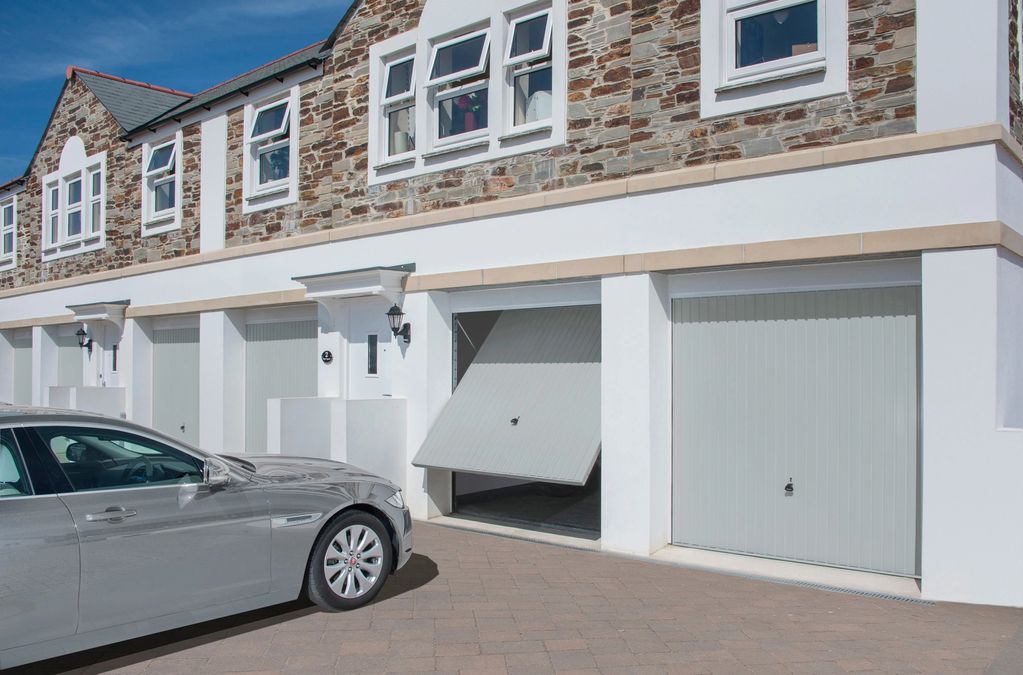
[217,0,917,245]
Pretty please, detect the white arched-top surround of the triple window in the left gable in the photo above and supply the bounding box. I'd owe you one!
[40,136,106,263]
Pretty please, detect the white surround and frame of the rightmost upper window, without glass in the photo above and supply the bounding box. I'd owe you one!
[700,0,849,118]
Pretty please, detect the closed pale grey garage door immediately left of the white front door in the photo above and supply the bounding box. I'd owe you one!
[246,321,318,452]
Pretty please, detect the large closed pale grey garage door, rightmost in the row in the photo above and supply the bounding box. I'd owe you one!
[672,287,920,576]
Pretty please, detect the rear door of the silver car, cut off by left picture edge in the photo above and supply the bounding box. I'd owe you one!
[0,429,79,650]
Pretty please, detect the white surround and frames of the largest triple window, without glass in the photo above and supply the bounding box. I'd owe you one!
[369,0,568,185]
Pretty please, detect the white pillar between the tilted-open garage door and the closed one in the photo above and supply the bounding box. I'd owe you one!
[601,274,671,555]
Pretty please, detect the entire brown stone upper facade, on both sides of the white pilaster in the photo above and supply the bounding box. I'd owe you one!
[0,0,920,288]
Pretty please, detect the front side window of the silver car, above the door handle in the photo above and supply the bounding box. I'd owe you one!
[36,426,203,492]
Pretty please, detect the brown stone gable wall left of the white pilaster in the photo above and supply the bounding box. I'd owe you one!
[0,77,199,288]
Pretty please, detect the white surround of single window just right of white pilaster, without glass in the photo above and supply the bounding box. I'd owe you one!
[241,84,301,214]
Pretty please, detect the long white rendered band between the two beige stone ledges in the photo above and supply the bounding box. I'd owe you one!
[0,144,997,325]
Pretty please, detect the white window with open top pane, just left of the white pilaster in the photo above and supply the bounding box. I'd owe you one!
[142,131,182,236]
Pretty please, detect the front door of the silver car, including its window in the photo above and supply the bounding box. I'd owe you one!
[26,425,270,633]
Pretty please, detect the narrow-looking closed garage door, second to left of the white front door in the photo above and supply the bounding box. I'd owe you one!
[152,327,198,445]
